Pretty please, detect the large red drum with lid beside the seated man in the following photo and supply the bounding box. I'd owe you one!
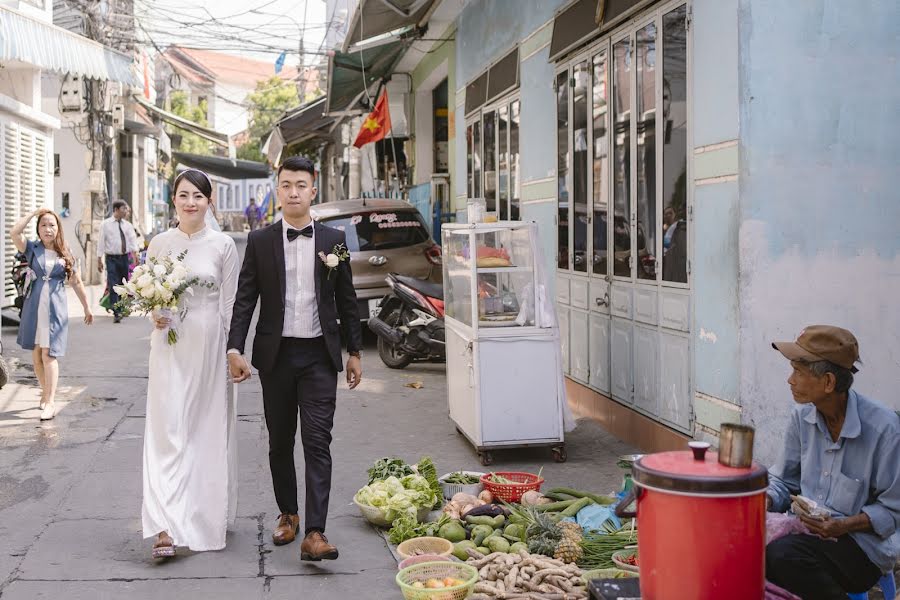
[634,442,768,600]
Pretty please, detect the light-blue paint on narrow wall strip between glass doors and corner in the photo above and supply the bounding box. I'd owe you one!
[690,0,741,408]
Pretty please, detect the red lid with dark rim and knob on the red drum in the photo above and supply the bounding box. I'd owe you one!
[633,444,769,496]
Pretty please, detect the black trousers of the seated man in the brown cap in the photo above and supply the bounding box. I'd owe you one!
[766,534,881,600]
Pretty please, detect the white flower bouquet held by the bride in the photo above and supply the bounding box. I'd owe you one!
[113,250,205,345]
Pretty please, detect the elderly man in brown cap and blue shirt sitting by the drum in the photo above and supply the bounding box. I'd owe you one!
[766,325,900,600]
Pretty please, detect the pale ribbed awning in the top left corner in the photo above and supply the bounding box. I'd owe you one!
[0,7,141,86]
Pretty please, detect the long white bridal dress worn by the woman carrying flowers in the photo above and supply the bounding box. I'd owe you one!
[141,226,240,551]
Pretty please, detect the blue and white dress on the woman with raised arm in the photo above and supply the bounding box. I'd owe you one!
[16,240,69,357]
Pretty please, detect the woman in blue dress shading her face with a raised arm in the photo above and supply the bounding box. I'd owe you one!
[9,208,94,421]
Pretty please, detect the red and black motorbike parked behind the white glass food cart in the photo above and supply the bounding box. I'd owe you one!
[369,273,445,369]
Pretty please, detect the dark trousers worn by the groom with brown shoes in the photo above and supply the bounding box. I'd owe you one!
[259,337,337,533]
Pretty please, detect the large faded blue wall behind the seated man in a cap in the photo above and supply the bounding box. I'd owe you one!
[739,0,900,458]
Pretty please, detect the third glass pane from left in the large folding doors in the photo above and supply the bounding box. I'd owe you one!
[591,52,609,275]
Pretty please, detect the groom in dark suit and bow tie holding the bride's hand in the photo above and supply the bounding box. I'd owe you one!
[228,156,362,560]
